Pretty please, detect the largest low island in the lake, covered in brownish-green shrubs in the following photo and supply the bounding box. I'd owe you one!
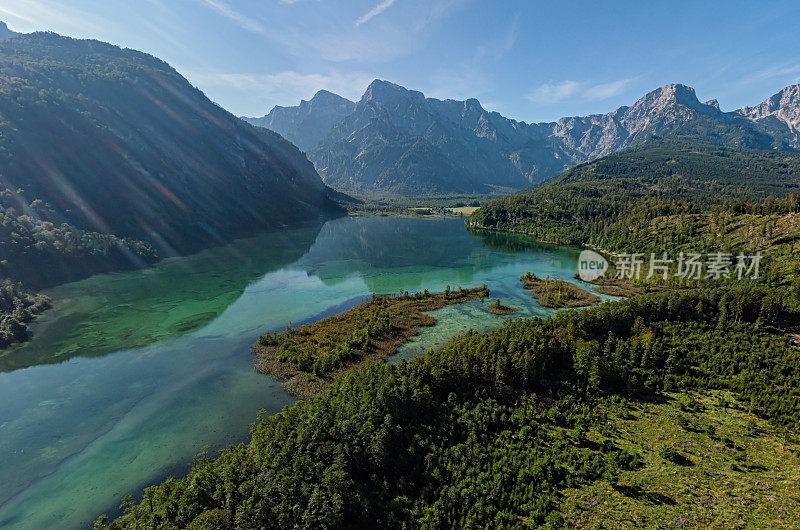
[252,285,489,397]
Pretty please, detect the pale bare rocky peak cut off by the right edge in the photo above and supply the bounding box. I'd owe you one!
[737,85,800,149]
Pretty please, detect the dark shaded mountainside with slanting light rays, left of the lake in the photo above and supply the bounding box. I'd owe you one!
[0,33,338,270]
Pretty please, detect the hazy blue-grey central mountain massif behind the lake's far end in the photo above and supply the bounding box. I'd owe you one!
[309,80,565,195]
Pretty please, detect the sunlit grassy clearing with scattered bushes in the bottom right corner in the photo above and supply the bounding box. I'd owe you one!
[561,392,800,529]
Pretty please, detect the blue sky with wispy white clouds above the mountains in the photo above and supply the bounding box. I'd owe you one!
[0,0,800,121]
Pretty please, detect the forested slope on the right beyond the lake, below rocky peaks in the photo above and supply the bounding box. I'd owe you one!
[468,139,800,257]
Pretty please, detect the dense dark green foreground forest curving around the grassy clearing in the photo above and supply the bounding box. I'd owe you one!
[97,286,800,528]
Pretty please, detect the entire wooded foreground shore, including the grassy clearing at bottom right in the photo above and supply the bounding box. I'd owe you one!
[100,286,800,528]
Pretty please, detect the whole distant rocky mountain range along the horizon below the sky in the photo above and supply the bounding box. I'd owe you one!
[245,80,800,196]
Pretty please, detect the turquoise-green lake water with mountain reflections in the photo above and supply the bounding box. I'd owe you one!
[0,218,605,528]
